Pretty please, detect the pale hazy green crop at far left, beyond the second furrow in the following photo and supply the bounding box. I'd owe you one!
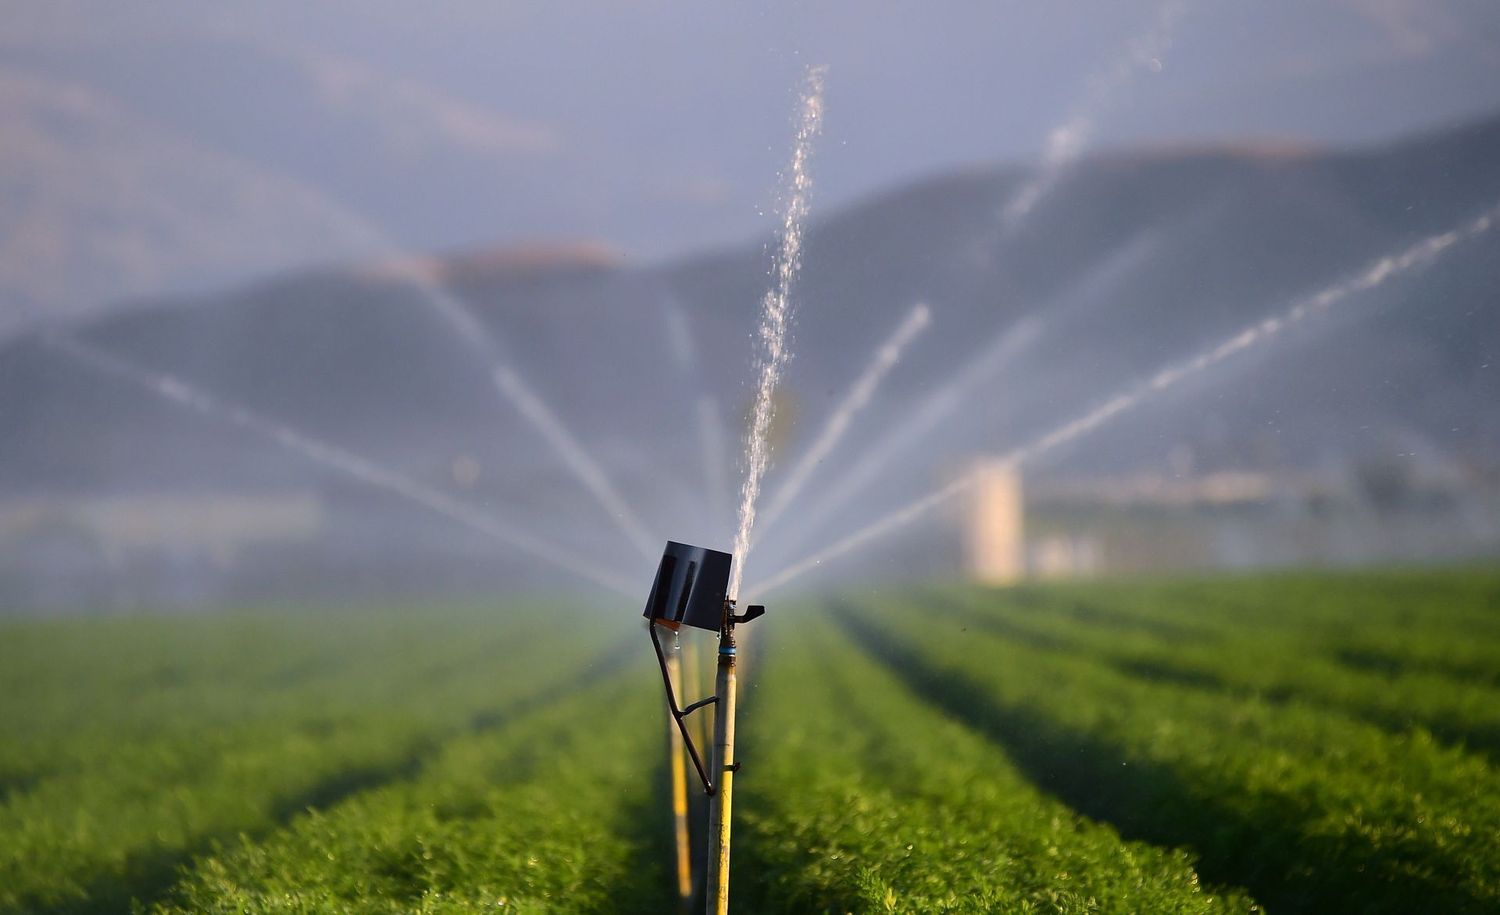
[0,612,540,786]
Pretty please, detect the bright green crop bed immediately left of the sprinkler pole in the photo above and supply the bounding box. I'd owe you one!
[153,666,671,915]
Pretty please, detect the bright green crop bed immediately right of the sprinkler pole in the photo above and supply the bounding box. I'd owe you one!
[734,608,1251,914]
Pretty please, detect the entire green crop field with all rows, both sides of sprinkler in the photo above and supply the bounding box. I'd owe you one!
[0,570,1500,914]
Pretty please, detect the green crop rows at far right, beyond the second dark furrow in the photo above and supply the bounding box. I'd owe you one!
[924,576,1500,756]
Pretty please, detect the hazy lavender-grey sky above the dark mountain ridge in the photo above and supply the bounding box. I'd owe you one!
[0,0,1500,319]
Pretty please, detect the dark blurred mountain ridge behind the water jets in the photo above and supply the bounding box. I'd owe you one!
[0,108,1500,585]
